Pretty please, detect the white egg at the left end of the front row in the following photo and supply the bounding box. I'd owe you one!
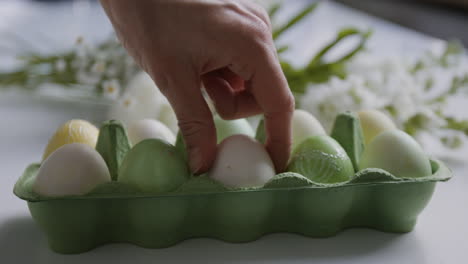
[33,143,111,197]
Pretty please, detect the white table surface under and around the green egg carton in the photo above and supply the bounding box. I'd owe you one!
[0,1,468,264]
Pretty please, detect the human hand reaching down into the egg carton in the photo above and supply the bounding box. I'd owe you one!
[101,0,294,173]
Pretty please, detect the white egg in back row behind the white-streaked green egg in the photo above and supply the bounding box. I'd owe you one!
[291,109,327,149]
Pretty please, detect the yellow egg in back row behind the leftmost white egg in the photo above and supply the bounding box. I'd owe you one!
[42,119,99,160]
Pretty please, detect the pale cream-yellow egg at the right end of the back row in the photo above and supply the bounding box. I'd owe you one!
[358,110,397,145]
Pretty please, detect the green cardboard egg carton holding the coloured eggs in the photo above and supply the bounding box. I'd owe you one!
[14,116,451,254]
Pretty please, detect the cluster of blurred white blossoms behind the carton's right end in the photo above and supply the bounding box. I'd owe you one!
[299,47,468,138]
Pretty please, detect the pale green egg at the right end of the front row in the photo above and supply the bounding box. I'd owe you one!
[359,130,432,178]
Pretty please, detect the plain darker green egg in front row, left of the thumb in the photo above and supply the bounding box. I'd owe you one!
[118,139,190,194]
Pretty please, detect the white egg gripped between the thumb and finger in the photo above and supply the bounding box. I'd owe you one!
[208,135,275,188]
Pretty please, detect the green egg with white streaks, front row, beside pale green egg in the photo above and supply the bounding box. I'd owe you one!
[288,135,354,183]
